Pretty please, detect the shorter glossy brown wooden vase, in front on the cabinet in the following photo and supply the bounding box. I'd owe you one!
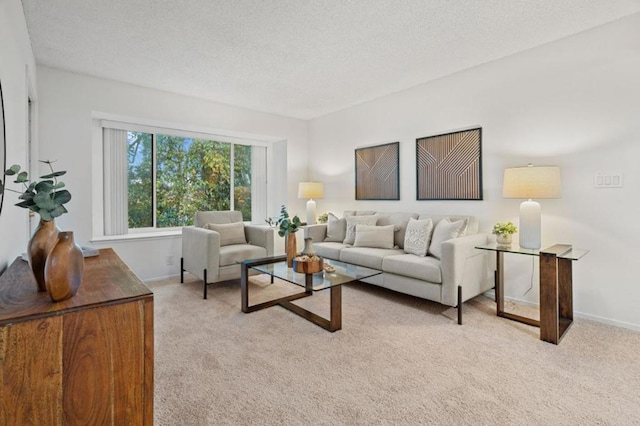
[44,232,84,302]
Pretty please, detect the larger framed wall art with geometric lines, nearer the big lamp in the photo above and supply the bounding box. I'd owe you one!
[416,127,482,200]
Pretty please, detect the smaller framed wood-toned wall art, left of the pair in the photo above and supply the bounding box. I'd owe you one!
[356,142,400,200]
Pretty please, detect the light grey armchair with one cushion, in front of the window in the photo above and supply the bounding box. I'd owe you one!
[180,211,273,299]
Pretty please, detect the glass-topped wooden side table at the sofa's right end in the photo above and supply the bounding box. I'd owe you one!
[476,243,589,345]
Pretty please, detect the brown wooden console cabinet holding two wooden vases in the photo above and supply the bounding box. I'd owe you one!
[0,249,153,425]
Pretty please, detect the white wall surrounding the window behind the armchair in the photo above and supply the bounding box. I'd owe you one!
[38,67,307,280]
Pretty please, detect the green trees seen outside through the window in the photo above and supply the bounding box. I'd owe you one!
[129,132,251,228]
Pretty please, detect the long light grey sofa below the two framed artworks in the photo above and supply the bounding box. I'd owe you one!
[304,211,494,323]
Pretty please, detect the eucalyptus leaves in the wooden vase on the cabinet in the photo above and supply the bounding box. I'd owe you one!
[0,161,71,222]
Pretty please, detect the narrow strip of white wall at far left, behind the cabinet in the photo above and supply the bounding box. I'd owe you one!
[0,0,36,272]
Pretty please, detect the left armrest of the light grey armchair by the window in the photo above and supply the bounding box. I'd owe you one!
[182,226,220,280]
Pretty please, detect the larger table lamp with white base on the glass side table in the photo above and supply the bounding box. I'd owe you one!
[502,164,561,249]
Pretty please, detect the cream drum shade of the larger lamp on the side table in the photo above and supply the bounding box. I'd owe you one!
[502,165,562,199]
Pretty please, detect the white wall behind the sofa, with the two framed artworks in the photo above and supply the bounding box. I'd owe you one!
[309,14,640,329]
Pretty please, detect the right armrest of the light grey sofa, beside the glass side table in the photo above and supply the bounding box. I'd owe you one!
[440,234,494,306]
